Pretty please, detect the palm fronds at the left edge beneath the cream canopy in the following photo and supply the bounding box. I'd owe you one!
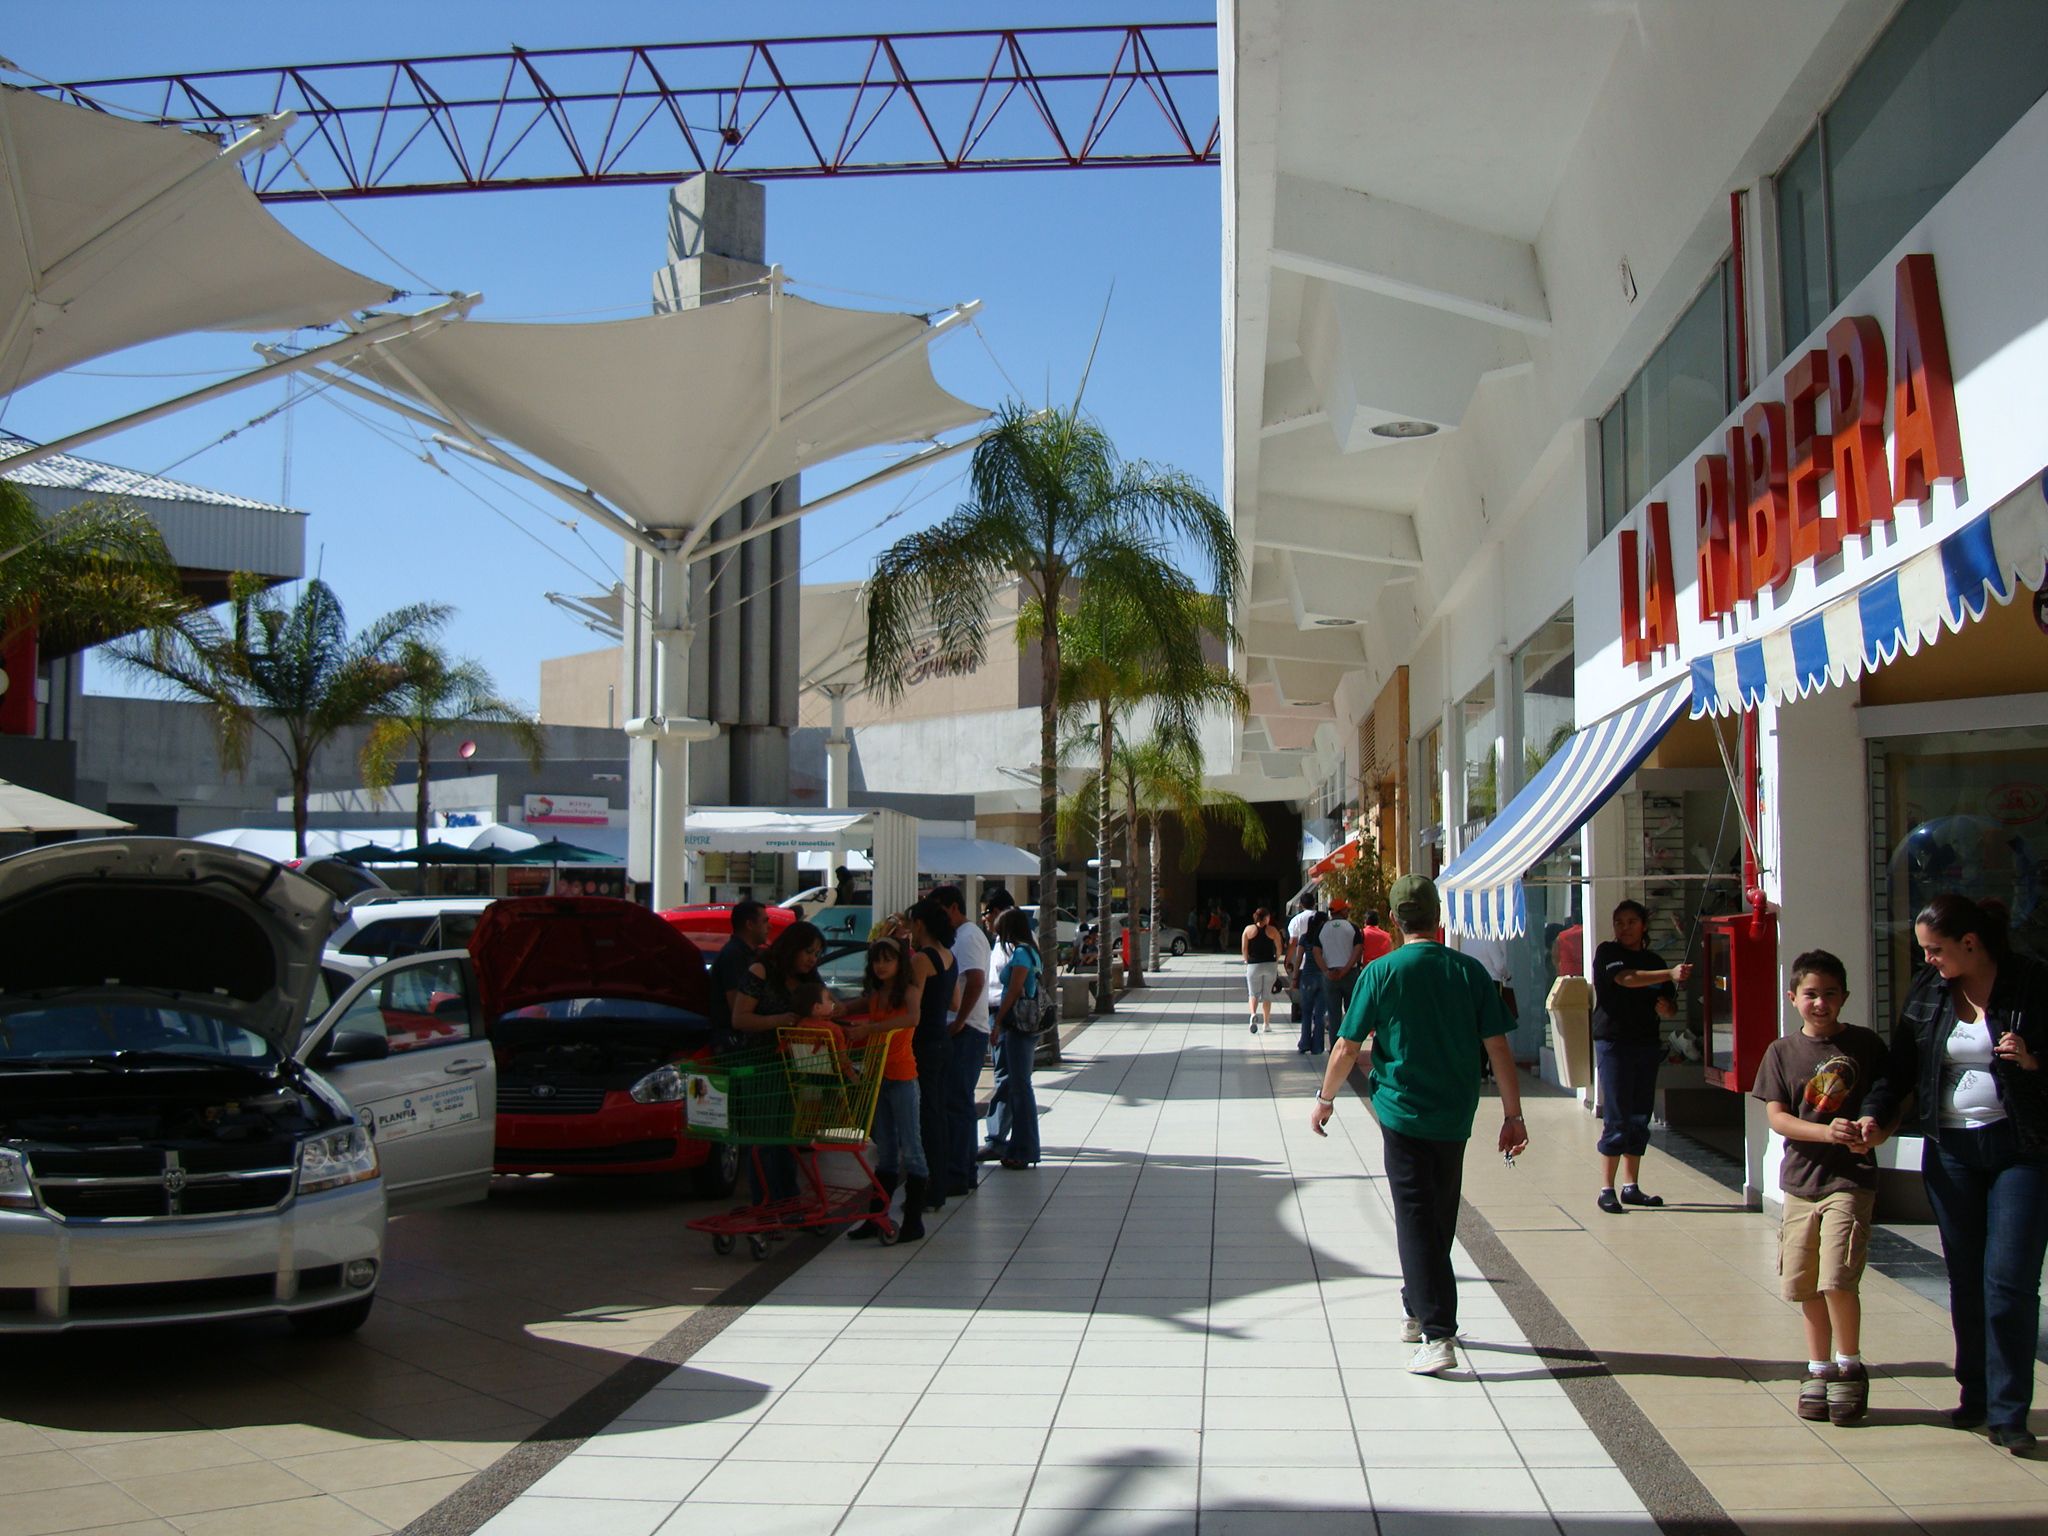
[0,481,193,653]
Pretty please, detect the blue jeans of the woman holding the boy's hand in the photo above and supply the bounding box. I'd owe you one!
[1921,1120,2048,1430]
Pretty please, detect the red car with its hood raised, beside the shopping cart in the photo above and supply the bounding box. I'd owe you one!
[483,897,739,1198]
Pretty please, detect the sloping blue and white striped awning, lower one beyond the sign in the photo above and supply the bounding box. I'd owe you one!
[1436,680,1692,938]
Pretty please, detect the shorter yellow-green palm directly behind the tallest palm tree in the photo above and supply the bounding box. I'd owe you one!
[1059,589,1251,1012]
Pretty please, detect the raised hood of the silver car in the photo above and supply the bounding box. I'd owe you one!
[0,838,336,1057]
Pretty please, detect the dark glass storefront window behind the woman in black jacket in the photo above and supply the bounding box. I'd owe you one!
[1870,727,2048,1018]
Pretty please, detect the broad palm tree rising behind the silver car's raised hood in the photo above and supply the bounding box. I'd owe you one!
[113,571,453,858]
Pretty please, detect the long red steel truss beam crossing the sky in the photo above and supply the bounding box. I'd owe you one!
[43,23,1221,203]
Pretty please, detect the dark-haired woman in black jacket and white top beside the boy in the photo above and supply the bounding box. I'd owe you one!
[1864,895,2048,1454]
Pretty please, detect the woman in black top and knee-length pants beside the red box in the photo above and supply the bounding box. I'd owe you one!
[1593,901,1692,1217]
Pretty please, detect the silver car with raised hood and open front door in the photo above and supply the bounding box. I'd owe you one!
[0,838,496,1333]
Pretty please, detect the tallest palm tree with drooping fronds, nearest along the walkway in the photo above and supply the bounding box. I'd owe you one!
[866,403,1241,1040]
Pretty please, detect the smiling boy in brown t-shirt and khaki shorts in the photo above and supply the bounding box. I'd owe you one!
[1753,950,1888,1423]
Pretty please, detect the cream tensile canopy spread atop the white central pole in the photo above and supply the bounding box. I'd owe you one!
[333,293,987,532]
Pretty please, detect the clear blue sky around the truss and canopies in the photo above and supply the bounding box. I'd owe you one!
[0,0,1223,702]
